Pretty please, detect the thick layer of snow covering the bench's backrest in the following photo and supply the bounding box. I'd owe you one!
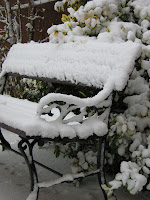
[1,39,141,91]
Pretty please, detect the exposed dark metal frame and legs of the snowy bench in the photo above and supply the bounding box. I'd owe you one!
[0,73,116,200]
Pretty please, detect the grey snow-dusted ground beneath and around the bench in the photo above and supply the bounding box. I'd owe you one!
[0,129,150,200]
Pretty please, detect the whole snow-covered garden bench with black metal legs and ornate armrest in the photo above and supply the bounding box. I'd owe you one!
[0,38,141,200]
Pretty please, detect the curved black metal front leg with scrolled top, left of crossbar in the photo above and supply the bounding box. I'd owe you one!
[18,138,39,199]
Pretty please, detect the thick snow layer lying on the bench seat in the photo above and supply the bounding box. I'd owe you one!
[0,95,108,139]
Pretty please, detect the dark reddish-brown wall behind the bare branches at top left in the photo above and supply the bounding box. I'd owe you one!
[0,0,62,43]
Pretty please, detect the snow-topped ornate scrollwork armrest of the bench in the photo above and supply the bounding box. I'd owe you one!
[37,83,114,124]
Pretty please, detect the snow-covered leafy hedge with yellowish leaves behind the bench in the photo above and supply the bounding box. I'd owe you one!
[48,0,150,194]
